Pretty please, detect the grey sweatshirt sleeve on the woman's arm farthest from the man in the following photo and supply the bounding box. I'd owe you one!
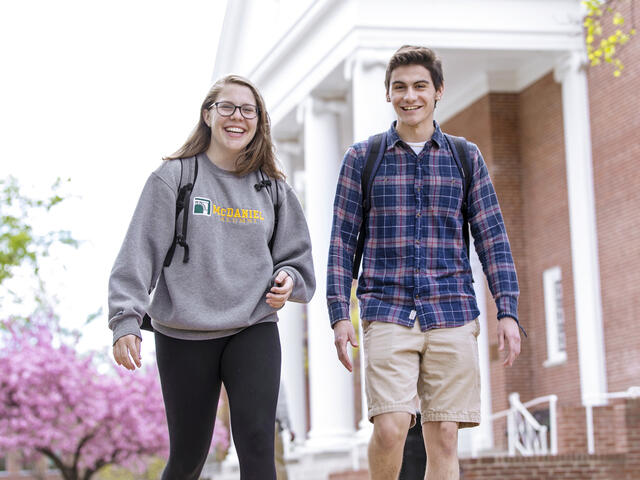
[109,173,176,344]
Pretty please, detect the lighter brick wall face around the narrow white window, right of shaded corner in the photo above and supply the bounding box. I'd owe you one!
[519,74,580,404]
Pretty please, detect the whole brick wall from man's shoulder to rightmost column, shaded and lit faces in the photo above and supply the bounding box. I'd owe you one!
[442,80,580,434]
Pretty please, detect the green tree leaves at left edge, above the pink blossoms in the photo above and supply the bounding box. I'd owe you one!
[0,176,77,284]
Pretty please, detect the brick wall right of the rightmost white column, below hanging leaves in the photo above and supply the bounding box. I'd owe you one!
[588,0,640,392]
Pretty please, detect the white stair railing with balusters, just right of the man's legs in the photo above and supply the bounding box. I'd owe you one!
[491,393,558,456]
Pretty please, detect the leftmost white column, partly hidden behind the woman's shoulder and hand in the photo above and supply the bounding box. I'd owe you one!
[277,142,307,443]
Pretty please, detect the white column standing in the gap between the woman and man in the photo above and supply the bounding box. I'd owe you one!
[300,98,354,451]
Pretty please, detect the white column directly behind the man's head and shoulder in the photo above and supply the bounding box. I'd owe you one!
[345,51,395,438]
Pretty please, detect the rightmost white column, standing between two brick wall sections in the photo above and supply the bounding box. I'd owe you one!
[554,52,607,405]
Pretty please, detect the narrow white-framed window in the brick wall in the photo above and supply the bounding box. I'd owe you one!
[542,267,567,367]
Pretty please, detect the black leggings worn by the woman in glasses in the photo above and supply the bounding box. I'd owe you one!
[155,322,280,480]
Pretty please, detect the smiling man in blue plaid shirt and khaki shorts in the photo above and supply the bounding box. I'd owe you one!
[327,46,520,480]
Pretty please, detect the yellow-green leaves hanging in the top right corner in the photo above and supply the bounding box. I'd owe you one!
[582,0,636,77]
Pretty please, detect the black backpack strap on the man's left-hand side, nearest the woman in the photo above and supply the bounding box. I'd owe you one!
[351,133,387,279]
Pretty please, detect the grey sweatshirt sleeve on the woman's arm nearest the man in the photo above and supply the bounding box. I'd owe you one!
[271,181,316,303]
